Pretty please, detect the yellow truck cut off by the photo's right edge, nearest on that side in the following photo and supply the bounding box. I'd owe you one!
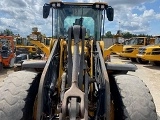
[137,36,160,66]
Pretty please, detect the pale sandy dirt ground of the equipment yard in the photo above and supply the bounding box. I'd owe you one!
[0,55,160,120]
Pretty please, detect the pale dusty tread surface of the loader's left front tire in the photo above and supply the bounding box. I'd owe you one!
[0,71,37,120]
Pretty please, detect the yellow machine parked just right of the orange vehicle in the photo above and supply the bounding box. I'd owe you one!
[15,36,37,55]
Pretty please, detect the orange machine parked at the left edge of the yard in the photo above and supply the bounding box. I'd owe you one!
[0,35,15,70]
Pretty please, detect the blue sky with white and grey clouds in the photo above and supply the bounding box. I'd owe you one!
[0,0,160,37]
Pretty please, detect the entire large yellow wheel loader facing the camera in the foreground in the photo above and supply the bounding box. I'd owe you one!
[0,1,157,120]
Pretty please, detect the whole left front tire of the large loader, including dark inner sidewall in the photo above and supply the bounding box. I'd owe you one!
[0,71,41,120]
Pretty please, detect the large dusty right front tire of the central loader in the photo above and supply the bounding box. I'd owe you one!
[110,75,157,120]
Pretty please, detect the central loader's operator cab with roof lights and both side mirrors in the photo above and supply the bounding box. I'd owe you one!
[43,2,113,40]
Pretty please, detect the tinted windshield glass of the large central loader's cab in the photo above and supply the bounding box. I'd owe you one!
[54,5,102,40]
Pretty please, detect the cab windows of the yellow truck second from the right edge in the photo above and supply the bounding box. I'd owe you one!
[128,38,144,45]
